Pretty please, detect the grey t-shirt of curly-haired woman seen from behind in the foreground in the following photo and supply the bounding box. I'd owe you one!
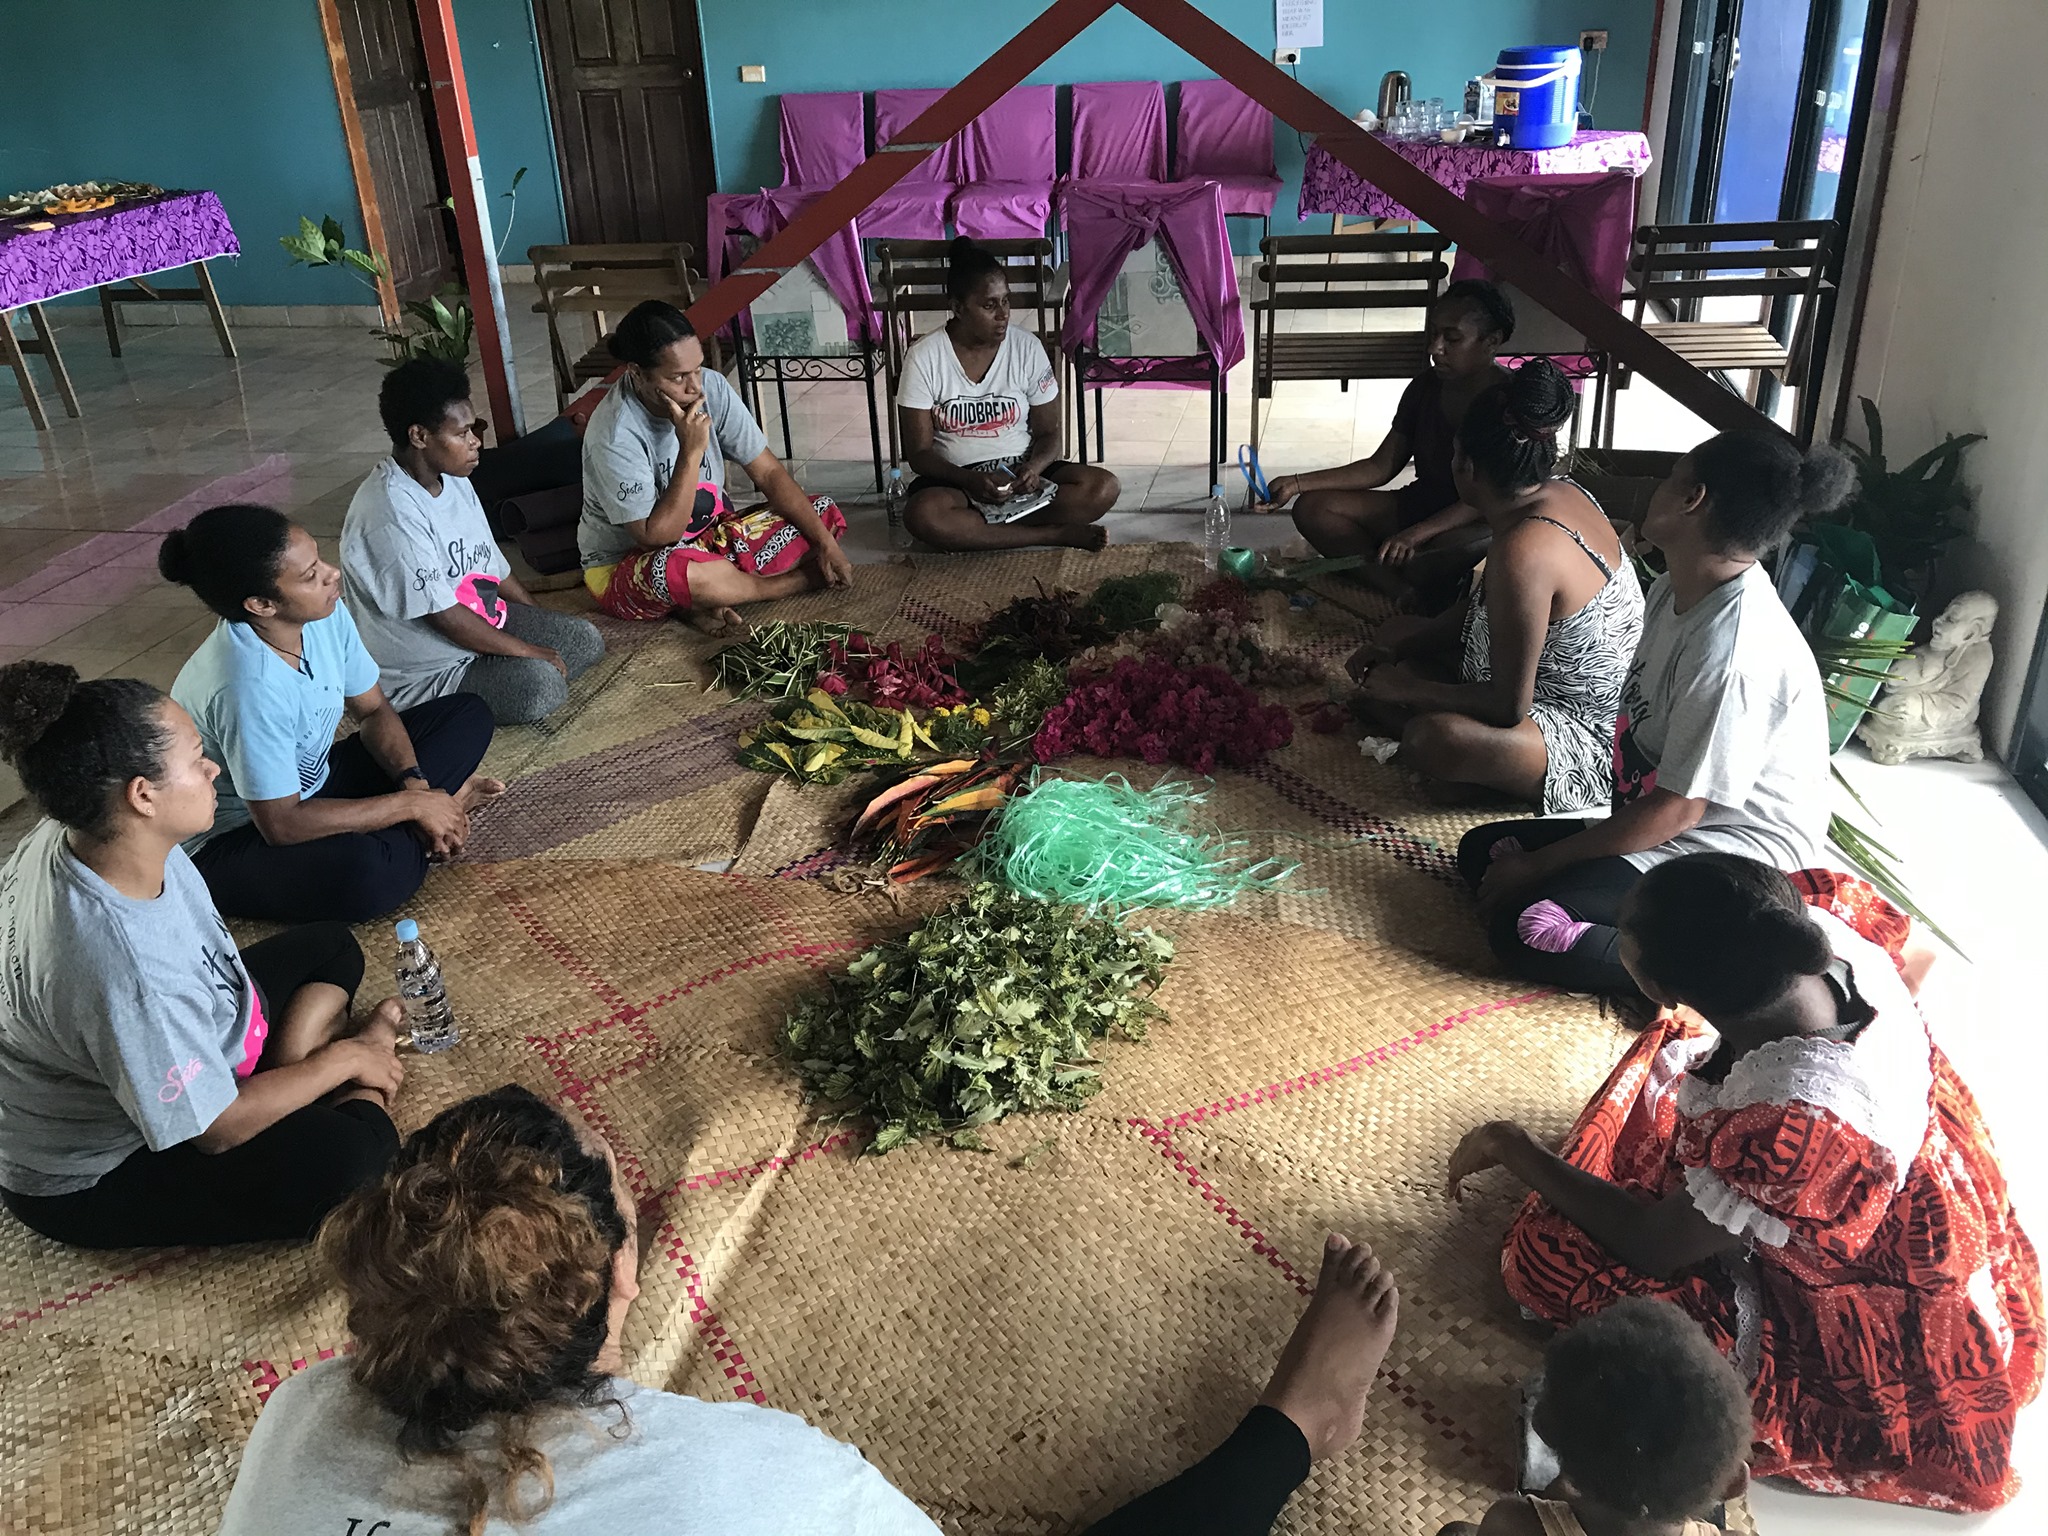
[221,1358,938,1536]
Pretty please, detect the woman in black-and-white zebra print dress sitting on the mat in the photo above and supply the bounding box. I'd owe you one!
[1354,358,1642,815]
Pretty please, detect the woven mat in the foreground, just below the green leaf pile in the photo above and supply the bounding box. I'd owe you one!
[633,918,1618,1532]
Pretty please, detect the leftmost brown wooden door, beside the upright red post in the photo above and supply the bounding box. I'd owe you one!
[340,0,457,299]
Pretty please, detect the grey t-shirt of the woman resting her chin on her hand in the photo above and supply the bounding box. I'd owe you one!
[575,369,768,567]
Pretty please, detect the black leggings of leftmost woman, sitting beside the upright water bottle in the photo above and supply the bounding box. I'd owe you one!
[0,924,397,1247]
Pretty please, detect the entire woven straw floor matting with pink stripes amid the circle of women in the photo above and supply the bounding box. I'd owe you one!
[0,547,1620,1536]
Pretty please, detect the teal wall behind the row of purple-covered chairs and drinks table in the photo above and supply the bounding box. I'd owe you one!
[698,0,1657,231]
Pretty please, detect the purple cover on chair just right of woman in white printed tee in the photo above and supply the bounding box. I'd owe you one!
[1059,180,1245,371]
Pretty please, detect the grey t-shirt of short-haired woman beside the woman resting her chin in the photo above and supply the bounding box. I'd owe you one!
[342,459,512,709]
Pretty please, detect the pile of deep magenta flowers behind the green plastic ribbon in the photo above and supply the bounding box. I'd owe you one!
[1032,657,1294,774]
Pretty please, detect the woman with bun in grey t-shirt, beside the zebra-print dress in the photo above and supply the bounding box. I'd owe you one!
[1458,430,1853,999]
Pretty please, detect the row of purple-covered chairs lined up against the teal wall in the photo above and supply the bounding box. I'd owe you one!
[778,80,1280,240]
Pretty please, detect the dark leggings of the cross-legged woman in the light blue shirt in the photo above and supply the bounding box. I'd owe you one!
[193,694,492,924]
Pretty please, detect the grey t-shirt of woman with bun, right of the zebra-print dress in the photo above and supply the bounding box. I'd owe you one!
[1614,565,1829,870]
